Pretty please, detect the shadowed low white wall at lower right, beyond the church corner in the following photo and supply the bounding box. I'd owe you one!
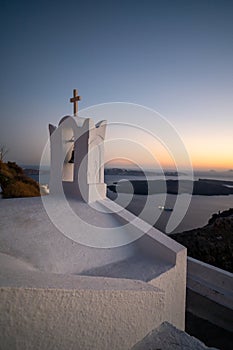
[187,257,233,332]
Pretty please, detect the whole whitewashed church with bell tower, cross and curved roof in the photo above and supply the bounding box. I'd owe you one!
[0,90,232,350]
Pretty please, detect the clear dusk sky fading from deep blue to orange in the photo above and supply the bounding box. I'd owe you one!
[0,0,233,170]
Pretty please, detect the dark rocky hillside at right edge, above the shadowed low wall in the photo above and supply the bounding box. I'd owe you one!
[171,209,233,272]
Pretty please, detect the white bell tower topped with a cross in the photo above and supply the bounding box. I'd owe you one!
[49,90,107,203]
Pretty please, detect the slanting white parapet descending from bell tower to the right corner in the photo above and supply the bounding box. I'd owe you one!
[98,199,187,330]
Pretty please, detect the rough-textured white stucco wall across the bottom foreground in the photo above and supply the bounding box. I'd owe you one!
[0,276,164,350]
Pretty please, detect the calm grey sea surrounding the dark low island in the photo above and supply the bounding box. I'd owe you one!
[24,166,233,234]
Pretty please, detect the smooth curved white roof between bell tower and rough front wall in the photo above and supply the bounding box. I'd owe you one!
[0,198,175,281]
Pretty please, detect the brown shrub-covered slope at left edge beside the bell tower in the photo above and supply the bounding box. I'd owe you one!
[0,161,40,198]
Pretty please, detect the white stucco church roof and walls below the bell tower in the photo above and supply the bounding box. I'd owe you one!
[0,197,186,350]
